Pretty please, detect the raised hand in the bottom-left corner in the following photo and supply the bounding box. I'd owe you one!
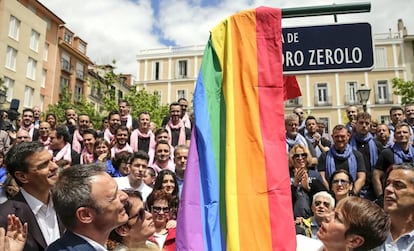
[0,214,27,251]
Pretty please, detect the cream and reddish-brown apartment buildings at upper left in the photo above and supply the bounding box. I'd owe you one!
[0,0,92,111]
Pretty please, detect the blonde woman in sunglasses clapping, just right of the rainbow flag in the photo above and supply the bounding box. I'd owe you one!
[289,144,326,218]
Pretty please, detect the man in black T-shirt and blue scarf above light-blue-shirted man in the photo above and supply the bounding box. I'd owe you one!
[372,123,414,199]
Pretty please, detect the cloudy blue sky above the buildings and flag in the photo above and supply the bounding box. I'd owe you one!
[39,0,414,75]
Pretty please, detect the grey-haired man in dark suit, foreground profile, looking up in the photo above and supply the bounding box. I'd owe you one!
[46,164,128,251]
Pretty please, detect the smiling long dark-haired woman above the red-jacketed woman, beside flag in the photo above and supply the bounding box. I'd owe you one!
[153,169,180,219]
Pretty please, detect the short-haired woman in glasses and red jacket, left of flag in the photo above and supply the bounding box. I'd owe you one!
[147,190,176,251]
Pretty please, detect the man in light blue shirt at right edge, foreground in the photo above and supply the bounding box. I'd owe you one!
[376,163,414,251]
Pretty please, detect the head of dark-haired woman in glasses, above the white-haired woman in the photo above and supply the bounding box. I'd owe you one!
[329,169,354,203]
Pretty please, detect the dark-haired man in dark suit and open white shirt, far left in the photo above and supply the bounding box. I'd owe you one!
[0,142,63,251]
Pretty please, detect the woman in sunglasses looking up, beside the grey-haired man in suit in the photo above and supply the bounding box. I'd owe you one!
[107,190,159,251]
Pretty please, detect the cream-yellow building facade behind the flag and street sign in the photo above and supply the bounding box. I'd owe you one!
[136,20,414,130]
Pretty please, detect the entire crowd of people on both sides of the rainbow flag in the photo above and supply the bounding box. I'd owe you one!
[0,99,414,251]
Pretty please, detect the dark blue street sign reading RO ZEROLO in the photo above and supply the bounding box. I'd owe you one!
[282,23,374,75]
